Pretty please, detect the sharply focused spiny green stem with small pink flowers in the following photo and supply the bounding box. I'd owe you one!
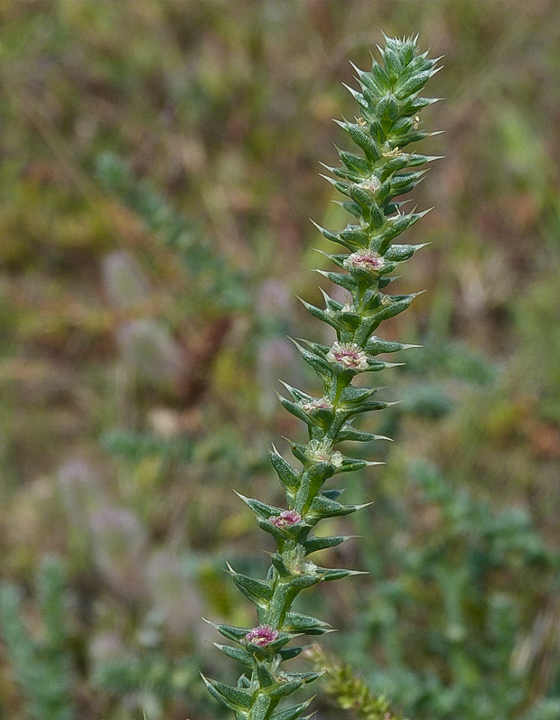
[205,38,437,720]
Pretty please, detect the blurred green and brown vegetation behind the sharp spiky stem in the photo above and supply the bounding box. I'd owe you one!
[0,0,560,720]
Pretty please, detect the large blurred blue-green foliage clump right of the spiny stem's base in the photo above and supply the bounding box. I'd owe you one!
[340,462,560,720]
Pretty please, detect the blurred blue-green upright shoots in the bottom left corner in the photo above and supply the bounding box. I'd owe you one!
[0,558,77,720]
